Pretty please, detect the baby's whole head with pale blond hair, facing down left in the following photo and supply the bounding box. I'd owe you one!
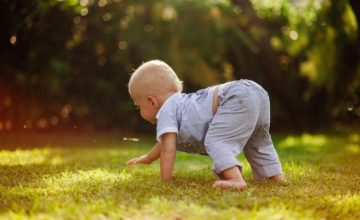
[128,60,182,124]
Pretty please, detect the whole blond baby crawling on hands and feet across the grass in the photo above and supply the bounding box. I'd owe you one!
[127,60,284,190]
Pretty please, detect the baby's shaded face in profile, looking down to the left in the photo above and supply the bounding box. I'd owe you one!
[131,88,158,124]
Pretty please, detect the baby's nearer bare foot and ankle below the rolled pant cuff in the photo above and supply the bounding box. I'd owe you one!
[213,166,246,190]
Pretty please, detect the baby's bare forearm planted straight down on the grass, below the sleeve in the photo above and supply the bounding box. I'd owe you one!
[160,133,176,180]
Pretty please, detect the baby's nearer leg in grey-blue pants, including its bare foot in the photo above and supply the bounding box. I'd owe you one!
[204,83,260,190]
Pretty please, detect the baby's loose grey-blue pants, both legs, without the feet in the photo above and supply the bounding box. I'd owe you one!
[205,80,282,179]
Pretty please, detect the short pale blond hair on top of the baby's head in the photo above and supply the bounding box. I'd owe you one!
[128,60,183,96]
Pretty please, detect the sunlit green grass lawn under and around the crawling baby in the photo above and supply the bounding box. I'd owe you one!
[0,132,360,219]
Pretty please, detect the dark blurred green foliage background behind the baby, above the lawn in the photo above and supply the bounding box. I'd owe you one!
[0,0,360,130]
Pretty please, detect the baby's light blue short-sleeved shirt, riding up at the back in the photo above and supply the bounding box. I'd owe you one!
[156,86,216,155]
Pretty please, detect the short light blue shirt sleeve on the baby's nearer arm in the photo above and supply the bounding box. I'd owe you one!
[156,103,179,142]
